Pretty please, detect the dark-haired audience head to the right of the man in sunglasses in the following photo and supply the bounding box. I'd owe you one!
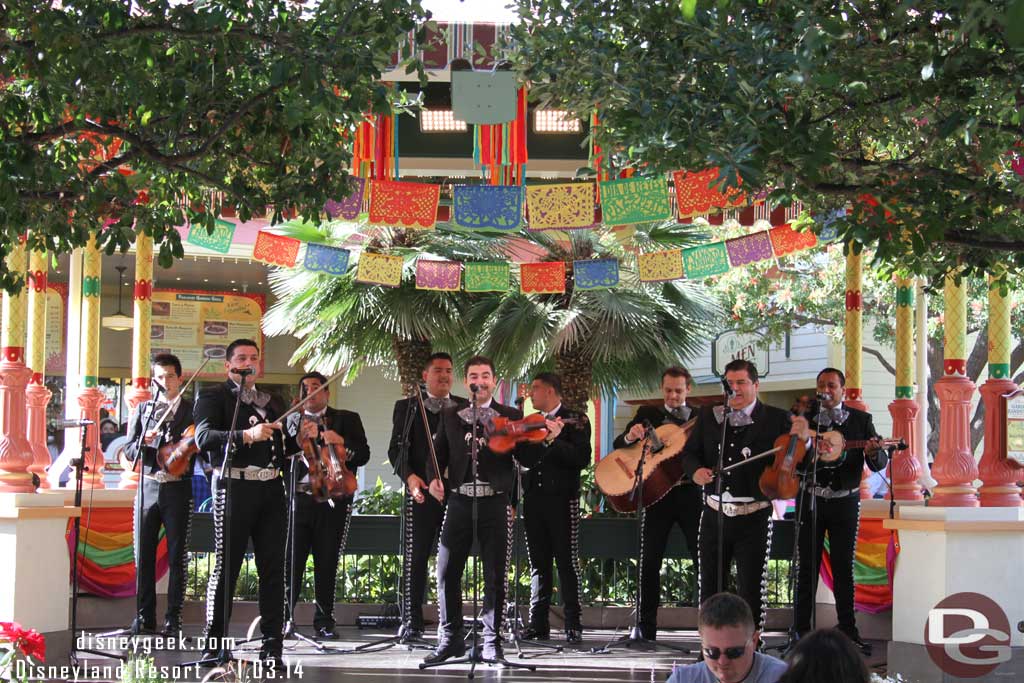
[778,629,871,683]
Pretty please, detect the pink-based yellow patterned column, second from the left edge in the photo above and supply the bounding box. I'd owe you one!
[25,245,50,488]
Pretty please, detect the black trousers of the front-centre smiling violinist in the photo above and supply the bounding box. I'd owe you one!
[437,494,514,643]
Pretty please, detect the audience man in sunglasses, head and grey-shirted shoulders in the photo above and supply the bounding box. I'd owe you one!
[669,593,786,683]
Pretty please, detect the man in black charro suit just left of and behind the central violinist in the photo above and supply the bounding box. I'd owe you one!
[387,352,469,638]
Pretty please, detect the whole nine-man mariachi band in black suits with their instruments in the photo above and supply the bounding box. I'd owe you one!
[125,339,892,666]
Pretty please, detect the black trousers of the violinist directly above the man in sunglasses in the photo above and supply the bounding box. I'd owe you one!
[697,505,772,630]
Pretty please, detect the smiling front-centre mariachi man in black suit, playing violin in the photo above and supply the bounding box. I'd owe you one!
[424,355,521,664]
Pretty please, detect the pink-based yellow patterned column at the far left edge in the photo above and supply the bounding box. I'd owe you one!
[0,238,36,494]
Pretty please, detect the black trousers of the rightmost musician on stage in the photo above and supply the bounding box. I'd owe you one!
[794,492,860,636]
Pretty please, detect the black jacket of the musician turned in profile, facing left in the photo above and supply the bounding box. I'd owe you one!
[516,405,593,497]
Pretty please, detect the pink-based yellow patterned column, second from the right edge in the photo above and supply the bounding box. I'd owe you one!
[931,273,978,508]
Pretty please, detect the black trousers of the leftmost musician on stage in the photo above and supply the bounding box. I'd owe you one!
[134,477,193,627]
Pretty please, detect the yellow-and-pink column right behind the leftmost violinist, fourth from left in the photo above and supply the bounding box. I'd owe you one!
[118,232,153,488]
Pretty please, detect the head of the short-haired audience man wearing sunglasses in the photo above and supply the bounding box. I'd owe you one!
[697,593,758,683]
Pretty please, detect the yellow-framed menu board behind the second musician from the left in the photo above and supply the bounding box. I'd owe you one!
[150,290,266,379]
